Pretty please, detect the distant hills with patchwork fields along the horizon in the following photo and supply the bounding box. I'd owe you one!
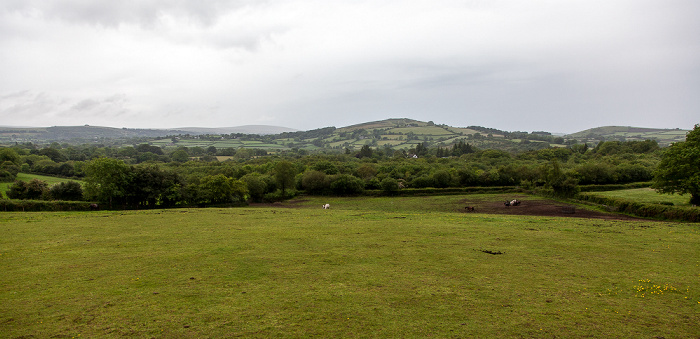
[0,118,688,152]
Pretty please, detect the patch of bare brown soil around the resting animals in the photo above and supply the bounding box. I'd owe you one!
[461,198,644,220]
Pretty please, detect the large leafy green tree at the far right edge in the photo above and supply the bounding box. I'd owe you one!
[654,125,700,205]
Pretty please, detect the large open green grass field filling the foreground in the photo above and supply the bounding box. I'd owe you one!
[0,196,700,338]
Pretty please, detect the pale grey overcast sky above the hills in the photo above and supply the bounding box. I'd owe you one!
[0,0,700,133]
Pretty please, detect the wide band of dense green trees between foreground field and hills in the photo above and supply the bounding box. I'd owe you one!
[0,126,700,208]
